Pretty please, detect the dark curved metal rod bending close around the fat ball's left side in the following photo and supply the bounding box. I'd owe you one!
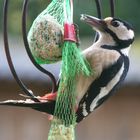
[22,0,57,93]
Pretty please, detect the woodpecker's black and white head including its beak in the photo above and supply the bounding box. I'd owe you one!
[81,14,134,49]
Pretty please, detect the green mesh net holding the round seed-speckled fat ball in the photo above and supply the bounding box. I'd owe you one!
[28,0,64,64]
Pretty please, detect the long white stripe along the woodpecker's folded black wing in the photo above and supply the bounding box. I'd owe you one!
[90,64,124,112]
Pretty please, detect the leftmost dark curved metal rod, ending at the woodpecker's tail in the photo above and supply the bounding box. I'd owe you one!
[3,0,39,102]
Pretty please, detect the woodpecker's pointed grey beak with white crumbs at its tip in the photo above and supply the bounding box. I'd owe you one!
[81,14,106,31]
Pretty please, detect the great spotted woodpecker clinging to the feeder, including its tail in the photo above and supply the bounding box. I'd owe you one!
[0,14,134,123]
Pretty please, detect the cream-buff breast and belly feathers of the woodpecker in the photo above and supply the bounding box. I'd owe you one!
[77,48,124,103]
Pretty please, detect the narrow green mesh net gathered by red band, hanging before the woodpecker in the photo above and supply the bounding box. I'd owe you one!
[48,0,91,140]
